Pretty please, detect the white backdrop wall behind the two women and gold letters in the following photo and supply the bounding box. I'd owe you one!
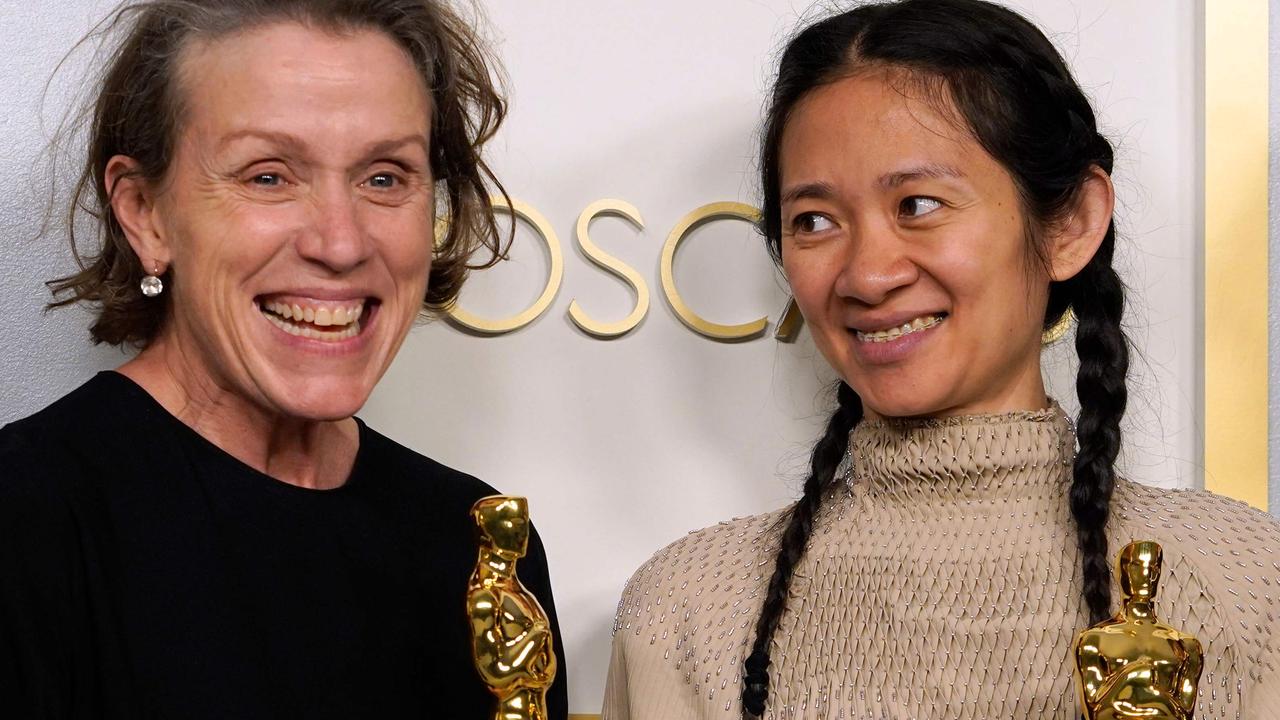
[0,0,1202,712]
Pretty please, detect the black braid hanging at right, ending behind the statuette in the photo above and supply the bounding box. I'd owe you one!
[1064,225,1129,623]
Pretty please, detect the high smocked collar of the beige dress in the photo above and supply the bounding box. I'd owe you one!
[847,404,1075,505]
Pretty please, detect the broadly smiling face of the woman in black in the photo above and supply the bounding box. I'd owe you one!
[140,23,434,420]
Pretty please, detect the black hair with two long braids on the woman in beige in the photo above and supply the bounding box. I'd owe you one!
[742,0,1129,716]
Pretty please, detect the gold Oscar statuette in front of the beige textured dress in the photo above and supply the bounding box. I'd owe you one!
[1075,541,1203,720]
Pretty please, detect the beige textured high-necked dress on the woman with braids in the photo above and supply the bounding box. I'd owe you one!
[604,410,1280,720]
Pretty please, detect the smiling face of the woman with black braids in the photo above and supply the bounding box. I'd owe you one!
[780,70,1048,416]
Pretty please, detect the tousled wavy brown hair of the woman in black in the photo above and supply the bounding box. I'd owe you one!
[46,0,511,347]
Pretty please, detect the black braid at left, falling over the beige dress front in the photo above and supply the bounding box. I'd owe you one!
[742,382,863,717]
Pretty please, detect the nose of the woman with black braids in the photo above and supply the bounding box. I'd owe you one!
[835,213,920,305]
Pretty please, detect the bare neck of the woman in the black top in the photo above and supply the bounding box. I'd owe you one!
[118,336,360,489]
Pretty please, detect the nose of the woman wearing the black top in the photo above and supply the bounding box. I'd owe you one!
[297,182,372,274]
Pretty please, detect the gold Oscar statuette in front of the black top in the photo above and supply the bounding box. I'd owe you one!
[467,495,556,720]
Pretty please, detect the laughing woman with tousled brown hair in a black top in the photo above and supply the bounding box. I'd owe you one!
[0,0,567,720]
